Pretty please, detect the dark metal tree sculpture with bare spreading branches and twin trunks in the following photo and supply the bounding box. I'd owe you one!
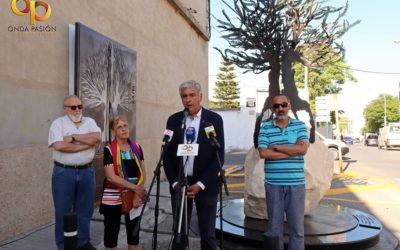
[215,0,358,146]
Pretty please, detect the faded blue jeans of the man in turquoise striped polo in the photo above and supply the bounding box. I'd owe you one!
[265,183,306,250]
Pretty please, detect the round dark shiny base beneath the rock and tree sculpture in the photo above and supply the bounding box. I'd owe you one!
[216,199,382,250]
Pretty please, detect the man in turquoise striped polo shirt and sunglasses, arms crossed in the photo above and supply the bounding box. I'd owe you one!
[258,94,309,250]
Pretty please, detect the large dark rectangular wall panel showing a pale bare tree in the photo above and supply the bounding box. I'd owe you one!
[74,23,136,150]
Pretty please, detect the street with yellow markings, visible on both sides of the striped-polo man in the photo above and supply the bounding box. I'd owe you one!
[224,146,400,249]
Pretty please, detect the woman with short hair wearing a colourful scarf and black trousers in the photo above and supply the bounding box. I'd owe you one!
[100,116,147,250]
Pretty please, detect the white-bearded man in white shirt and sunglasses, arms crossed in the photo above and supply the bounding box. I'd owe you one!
[48,95,101,250]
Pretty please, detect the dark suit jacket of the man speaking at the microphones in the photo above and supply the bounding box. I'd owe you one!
[163,108,225,194]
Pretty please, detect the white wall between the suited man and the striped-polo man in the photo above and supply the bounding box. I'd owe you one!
[214,106,256,152]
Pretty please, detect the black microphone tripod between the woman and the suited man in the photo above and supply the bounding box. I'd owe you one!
[133,140,169,250]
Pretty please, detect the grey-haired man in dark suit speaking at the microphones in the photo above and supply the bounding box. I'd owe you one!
[163,80,225,250]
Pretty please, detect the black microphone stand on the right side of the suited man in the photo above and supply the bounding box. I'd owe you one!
[210,136,229,249]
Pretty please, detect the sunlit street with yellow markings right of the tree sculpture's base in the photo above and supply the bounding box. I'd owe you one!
[332,143,400,245]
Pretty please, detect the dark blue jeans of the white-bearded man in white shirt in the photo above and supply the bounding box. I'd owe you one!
[51,165,96,250]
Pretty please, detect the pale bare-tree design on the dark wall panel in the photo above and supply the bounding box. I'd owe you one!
[81,43,136,141]
